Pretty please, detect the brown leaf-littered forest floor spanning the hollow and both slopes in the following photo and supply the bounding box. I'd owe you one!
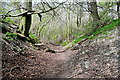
[2,29,119,79]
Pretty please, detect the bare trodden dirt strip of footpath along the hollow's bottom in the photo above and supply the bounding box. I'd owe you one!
[45,50,77,78]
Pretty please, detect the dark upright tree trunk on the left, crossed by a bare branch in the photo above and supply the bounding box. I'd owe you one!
[24,0,32,37]
